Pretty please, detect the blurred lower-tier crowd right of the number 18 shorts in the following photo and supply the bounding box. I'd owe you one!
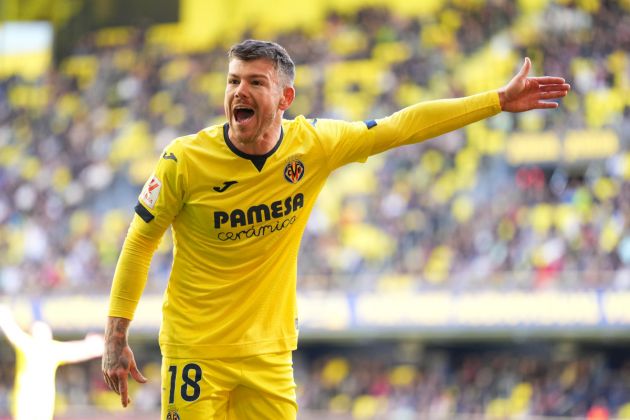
[296,343,630,420]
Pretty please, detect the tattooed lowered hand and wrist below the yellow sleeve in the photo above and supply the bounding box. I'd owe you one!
[103,316,147,407]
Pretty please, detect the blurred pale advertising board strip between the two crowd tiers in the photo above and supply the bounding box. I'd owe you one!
[0,290,630,339]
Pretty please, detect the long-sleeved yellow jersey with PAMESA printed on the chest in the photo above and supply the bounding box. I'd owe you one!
[109,91,501,359]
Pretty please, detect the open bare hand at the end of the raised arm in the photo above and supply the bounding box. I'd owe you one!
[499,57,571,112]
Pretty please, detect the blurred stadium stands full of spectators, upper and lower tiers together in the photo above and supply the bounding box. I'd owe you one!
[0,0,630,419]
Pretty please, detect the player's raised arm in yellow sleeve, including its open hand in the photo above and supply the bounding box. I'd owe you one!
[313,58,571,171]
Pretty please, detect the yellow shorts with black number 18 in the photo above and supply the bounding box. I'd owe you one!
[161,351,297,420]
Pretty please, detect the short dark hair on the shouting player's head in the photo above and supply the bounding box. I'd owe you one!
[228,39,295,85]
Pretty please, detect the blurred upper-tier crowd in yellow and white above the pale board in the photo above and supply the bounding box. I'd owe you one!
[0,0,630,295]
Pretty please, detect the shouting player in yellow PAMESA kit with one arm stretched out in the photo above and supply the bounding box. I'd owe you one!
[103,40,570,420]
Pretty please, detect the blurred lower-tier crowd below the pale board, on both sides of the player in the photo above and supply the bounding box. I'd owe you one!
[0,341,630,420]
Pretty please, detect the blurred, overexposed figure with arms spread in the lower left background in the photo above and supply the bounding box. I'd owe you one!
[0,305,103,420]
